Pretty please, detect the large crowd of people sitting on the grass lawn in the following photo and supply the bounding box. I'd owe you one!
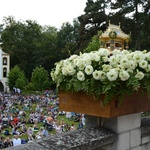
[0,90,85,149]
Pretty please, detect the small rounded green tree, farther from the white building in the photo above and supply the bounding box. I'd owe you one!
[31,66,50,91]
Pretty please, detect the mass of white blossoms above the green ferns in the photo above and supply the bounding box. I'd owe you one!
[51,48,150,83]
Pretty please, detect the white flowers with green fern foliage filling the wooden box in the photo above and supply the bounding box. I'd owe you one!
[51,48,150,105]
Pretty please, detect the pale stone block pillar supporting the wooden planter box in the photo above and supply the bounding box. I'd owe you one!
[101,113,141,150]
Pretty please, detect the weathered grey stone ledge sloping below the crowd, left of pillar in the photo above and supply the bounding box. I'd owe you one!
[7,128,117,150]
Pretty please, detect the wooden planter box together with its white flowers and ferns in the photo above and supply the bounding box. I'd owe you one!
[51,48,150,118]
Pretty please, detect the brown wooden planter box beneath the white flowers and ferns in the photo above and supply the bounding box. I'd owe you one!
[59,91,150,118]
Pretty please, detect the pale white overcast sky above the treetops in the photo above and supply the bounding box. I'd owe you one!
[0,0,87,28]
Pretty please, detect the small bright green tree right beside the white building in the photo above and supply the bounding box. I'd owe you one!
[7,65,27,90]
